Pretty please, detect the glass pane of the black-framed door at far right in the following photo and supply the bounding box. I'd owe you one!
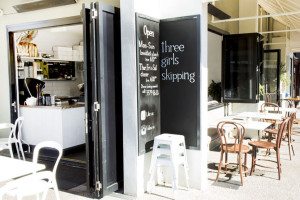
[260,51,279,103]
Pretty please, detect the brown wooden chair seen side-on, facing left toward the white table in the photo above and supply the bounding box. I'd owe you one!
[248,118,290,180]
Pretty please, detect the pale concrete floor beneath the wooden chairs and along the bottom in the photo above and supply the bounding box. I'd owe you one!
[0,120,300,200]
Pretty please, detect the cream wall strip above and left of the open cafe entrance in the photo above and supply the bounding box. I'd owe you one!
[0,0,120,122]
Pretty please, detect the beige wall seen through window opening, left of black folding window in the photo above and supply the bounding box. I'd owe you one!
[207,32,222,85]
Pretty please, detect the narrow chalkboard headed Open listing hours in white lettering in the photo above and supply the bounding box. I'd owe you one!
[136,14,161,155]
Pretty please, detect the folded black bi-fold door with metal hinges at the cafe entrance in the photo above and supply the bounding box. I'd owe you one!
[84,2,123,198]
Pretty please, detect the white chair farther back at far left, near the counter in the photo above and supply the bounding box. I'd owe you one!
[0,117,25,160]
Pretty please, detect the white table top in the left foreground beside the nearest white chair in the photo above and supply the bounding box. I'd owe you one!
[0,156,46,182]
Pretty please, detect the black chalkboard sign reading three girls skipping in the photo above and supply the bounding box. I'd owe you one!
[160,15,200,149]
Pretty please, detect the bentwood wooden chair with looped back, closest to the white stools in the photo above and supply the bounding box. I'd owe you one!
[216,121,250,185]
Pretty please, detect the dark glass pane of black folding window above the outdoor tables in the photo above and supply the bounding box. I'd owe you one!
[224,37,255,100]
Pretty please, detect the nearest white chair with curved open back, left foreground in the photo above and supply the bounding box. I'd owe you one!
[0,141,62,200]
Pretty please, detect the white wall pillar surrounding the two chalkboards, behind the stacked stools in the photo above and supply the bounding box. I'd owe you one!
[121,0,207,196]
